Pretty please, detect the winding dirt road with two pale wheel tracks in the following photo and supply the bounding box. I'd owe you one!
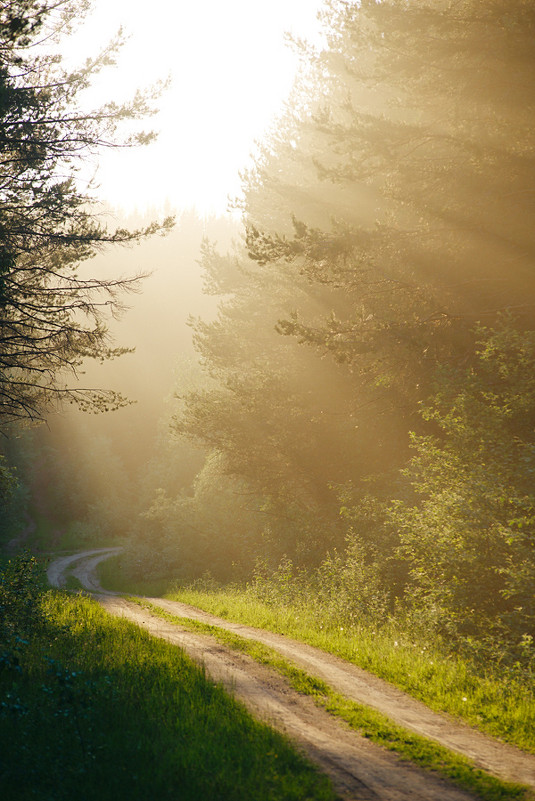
[48,548,535,801]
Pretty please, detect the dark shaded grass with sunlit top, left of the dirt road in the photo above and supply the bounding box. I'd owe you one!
[0,592,335,801]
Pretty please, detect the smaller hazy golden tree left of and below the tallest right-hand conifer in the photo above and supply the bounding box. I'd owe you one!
[173,228,390,562]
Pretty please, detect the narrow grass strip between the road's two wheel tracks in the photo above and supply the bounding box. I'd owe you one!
[131,598,533,801]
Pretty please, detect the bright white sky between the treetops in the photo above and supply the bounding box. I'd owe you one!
[62,0,321,213]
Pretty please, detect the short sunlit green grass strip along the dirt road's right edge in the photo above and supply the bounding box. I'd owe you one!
[146,588,535,753]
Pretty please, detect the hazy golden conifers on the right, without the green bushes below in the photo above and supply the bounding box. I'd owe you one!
[170,0,535,580]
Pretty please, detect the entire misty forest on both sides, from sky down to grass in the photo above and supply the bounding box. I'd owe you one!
[0,0,535,670]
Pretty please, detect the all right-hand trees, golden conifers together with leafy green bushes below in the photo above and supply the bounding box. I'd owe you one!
[170,0,535,636]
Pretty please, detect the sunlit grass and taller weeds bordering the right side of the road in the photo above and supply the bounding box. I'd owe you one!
[99,557,535,753]
